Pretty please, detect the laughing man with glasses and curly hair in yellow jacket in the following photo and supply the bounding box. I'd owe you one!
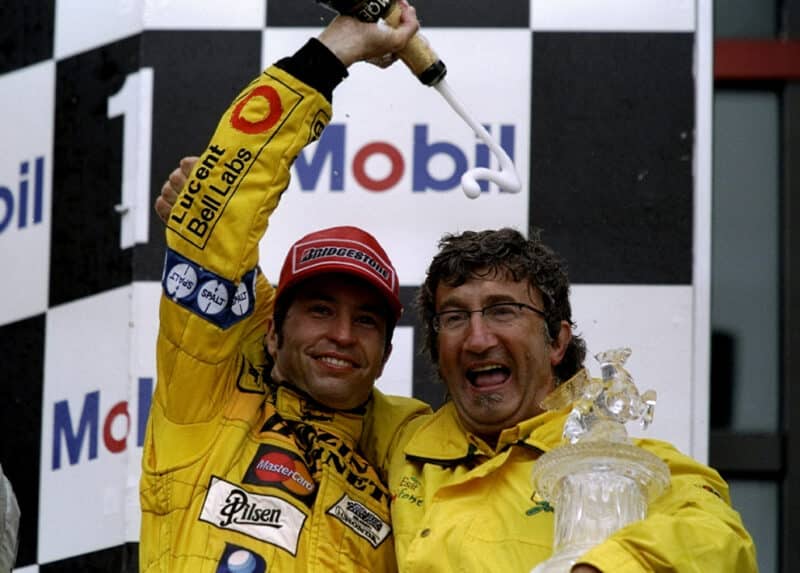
[362,229,757,573]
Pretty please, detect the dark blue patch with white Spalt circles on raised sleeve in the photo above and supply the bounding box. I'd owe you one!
[161,249,258,329]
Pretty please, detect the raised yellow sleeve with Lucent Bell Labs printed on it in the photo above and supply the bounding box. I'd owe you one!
[144,66,331,471]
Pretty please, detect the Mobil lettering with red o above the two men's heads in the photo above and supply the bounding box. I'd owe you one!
[294,123,516,193]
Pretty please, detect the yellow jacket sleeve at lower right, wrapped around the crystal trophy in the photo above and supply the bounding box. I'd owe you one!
[579,440,758,573]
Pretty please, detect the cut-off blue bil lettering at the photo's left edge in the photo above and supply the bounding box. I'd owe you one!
[0,156,44,235]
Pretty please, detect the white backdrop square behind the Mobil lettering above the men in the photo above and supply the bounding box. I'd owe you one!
[261,29,531,285]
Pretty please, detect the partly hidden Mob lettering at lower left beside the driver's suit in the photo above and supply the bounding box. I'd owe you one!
[51,378,153,470]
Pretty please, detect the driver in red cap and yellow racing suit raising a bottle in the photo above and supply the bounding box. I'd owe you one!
[140,5,426,573]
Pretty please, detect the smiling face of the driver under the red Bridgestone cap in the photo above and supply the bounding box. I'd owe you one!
[267,274,391,409]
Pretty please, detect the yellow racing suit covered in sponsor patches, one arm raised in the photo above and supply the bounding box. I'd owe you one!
[139,41,432,573]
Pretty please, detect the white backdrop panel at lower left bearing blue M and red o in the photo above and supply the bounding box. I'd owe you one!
[39,286,139,562]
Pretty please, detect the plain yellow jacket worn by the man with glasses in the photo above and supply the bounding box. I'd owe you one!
[362,370,758,573]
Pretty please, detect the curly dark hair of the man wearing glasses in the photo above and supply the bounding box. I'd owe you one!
[415,228,586,381]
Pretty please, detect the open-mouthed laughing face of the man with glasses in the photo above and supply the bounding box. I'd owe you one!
[436,275,570,442]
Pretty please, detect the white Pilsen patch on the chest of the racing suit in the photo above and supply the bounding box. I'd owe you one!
[200,476,306,555]
